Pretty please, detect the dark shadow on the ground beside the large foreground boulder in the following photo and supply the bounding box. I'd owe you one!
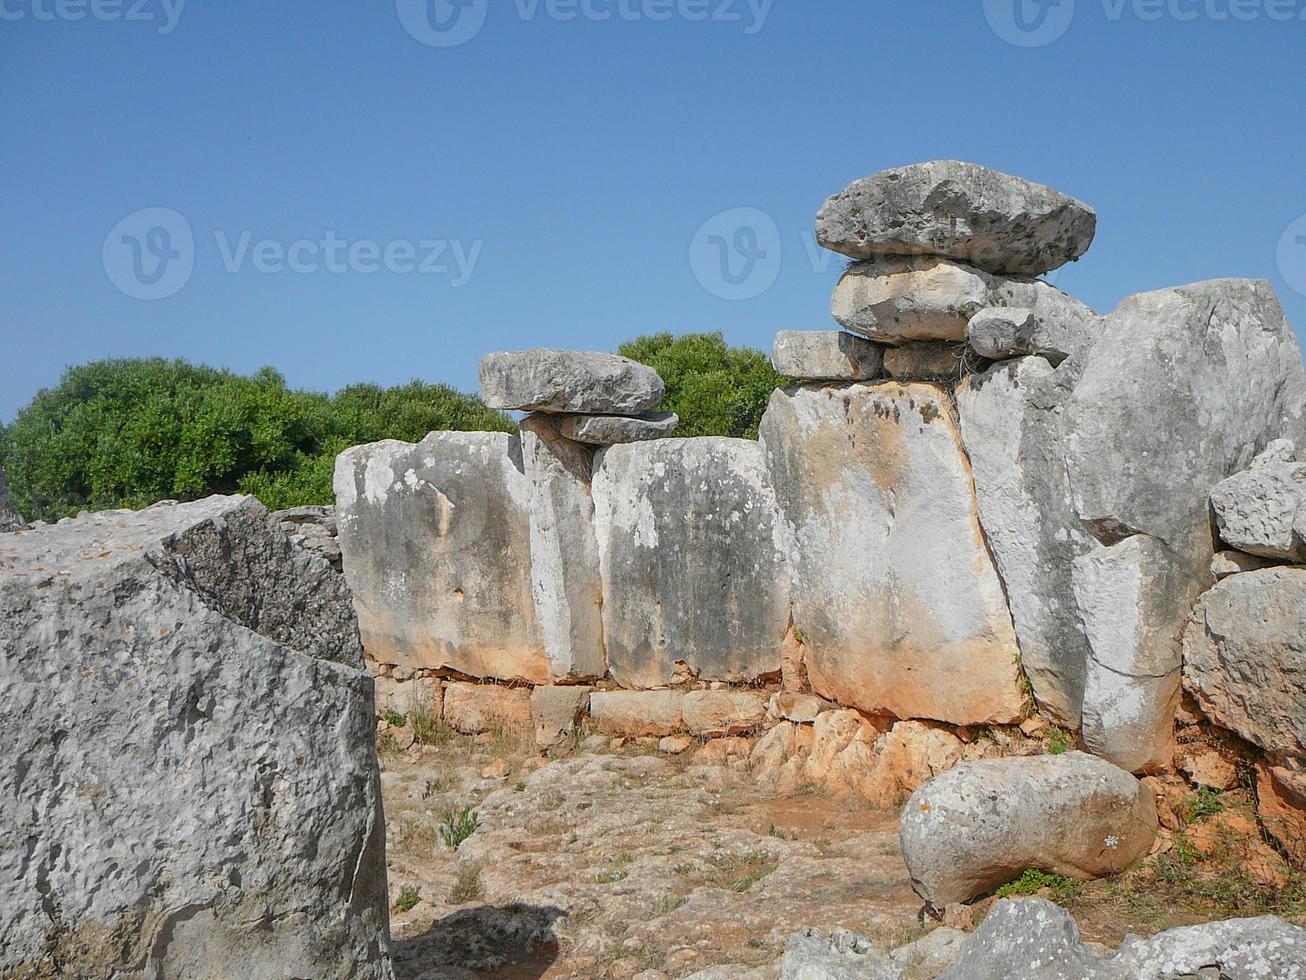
[393,904,567,980]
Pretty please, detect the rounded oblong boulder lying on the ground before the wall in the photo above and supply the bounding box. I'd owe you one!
[901,751,1156,908]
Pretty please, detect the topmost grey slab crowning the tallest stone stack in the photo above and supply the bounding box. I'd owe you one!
[816,159,1097,276]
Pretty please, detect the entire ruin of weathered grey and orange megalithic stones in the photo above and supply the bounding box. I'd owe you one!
[0,162,1306,980]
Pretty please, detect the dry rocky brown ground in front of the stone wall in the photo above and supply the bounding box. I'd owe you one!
[381,730,1303,980]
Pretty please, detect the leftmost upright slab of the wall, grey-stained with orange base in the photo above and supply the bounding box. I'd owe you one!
[336,433,549,683]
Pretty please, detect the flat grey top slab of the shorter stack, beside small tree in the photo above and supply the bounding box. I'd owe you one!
[481,348,665,416]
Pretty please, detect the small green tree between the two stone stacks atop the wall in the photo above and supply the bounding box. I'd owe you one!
[619,333,782,439]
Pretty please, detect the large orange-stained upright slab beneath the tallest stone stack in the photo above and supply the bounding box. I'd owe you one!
[761,383,1024,724]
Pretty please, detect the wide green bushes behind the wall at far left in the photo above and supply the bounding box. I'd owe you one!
[0,358,516,520]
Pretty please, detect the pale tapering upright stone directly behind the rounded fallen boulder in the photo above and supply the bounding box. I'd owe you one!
[1071,534,1202,772]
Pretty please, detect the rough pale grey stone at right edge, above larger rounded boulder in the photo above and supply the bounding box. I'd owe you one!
[1211,457,1306,562]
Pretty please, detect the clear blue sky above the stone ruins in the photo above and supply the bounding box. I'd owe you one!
[0,0,1306,419]
